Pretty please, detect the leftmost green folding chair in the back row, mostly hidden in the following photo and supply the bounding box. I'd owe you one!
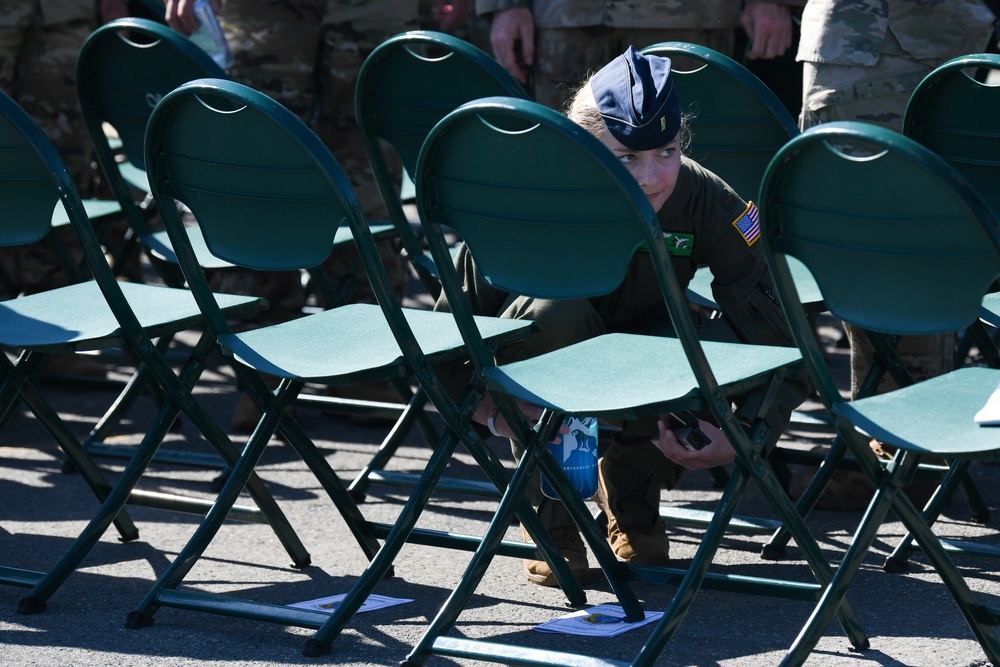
[77,18,408,467]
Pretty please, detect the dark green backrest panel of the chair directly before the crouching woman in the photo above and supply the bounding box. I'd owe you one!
[418,102,657,299]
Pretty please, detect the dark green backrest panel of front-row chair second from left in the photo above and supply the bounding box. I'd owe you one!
[145,79,348,320]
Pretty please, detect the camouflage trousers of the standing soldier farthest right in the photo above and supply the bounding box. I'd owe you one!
[800,31,956,396]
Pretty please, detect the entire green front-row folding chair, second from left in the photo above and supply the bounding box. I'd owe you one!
[127,79,582,655]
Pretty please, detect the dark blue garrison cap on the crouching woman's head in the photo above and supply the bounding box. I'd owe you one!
[590,46,681,151]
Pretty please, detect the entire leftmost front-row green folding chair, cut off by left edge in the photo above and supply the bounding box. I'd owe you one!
[0,88,308,613]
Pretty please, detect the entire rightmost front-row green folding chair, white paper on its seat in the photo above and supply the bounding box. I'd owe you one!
[760,122,1000,665]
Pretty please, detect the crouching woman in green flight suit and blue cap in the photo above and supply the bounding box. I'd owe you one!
[438,47,806,585]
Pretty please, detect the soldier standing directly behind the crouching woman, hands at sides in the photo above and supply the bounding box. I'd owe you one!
[476,0,804,109]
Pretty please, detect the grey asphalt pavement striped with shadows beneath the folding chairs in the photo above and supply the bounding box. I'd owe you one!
[0,306,1000,667]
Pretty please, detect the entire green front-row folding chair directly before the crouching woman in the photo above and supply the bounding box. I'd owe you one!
[404,98,868,665]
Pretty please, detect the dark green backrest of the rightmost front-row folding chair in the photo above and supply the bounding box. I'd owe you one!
[761,123,997,344]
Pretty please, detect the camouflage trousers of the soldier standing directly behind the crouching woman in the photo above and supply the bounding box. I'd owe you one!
[530,26,736,109]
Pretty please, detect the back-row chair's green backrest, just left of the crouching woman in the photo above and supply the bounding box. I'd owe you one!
[354,30,528,295]
